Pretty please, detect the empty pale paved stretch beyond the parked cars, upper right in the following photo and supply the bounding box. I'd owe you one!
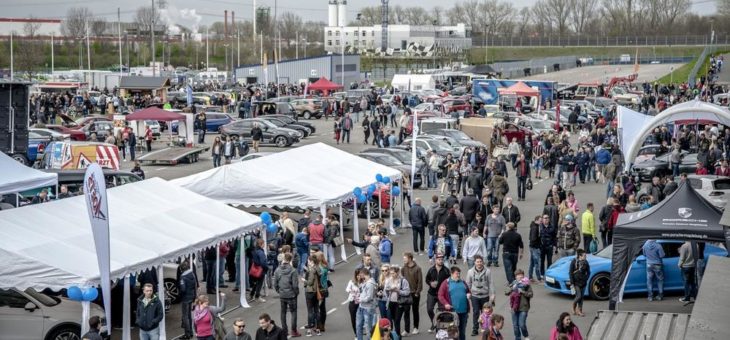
[524,64,682,84]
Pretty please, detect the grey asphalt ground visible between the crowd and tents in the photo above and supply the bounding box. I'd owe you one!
[114,115,691,340]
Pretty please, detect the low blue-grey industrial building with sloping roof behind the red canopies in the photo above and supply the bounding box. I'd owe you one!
[235,54,360,87]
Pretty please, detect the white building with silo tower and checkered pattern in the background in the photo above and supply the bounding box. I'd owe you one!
[323,0,471,53]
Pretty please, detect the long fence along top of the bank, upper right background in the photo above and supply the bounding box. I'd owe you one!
[472,34,730,47]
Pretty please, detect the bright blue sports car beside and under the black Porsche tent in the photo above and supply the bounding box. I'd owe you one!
[545,240,727,300]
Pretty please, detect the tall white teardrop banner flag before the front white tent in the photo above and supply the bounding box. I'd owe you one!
[84,163,112,335]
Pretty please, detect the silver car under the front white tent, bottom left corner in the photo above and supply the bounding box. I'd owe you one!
[0,288,107,340]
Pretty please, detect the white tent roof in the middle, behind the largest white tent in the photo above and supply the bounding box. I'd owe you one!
[172,143,402,208]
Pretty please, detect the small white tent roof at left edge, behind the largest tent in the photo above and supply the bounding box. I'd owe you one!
[0,152,58,195]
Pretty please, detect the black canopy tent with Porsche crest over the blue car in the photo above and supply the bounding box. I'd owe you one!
[609,183,730,310]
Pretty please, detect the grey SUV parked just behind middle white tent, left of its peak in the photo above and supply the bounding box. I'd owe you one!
[220,118,303,148]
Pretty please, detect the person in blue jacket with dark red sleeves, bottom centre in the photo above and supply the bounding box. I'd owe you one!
[438,266,471,340]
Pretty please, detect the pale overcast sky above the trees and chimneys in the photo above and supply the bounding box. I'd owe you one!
[0,0,715,27]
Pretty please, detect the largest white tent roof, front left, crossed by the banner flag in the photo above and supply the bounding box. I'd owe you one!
[0,178,261,290]
